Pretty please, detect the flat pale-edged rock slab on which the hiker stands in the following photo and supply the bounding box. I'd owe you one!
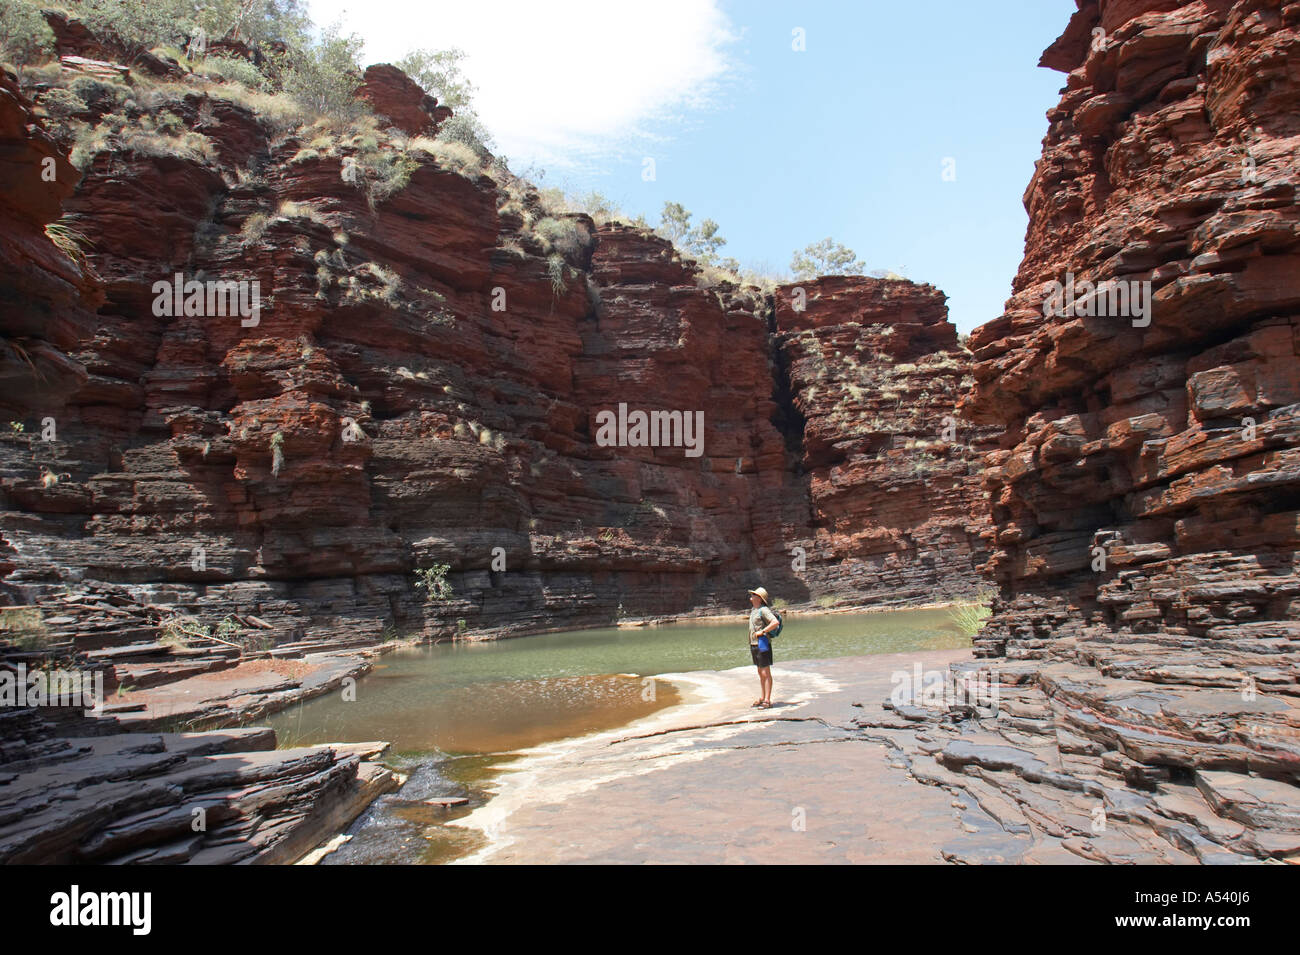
[456,651,1034,864]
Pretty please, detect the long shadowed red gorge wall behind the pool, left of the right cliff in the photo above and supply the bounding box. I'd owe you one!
[0,57,982,646]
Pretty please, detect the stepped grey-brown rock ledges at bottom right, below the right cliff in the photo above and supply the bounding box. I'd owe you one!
[854,660,1300,864]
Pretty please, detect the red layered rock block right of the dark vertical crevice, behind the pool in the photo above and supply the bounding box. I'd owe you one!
[775,277,989,604]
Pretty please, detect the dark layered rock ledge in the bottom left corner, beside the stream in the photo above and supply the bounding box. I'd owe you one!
[0,707,399,865]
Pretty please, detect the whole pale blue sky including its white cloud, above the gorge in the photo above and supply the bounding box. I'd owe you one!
[311,0,1075,331]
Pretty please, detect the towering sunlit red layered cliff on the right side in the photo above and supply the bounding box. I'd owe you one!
[965,0,1300,773]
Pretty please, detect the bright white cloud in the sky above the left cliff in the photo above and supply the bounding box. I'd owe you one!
[302,0,737,166]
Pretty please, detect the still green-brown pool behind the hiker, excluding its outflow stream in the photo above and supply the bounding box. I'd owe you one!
[272,611,970,754]
